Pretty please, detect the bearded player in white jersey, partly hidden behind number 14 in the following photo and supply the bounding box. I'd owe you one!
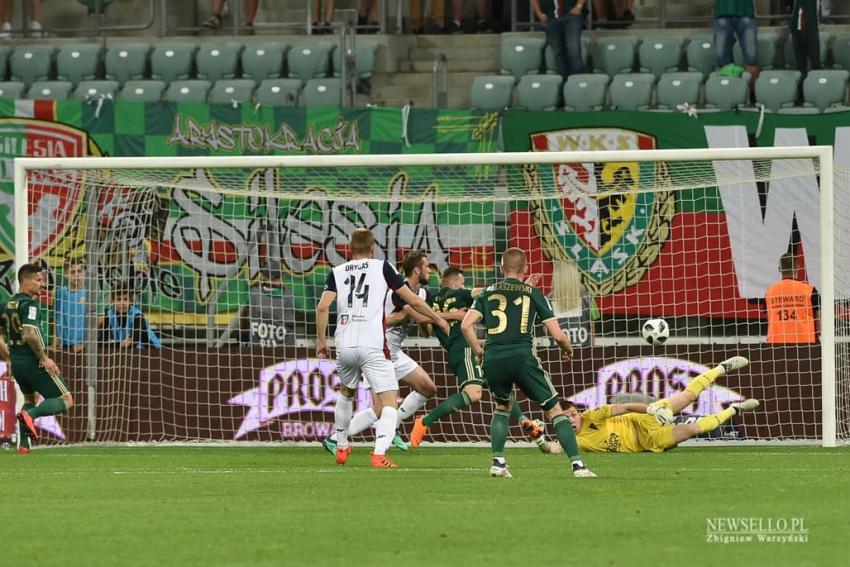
[322,251,444,453]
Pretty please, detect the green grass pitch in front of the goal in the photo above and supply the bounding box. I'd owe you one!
[0,446,850,567]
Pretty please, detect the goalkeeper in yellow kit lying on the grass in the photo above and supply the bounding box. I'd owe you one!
[566,356,759,453]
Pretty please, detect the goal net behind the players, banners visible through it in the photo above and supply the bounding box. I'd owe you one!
[4,148,850,444]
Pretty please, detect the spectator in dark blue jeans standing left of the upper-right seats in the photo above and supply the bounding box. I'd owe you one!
[531,0,587,80]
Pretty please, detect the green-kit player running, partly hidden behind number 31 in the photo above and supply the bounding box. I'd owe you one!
[410,267,548,452]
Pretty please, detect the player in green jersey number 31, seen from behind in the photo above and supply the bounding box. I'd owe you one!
[460,248,596,478]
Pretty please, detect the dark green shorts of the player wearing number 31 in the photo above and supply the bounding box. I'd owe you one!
[484,355,558,411]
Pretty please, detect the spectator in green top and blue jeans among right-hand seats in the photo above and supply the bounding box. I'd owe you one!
[714,0,759,84]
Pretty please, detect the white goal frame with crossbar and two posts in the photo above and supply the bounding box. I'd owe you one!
[14,146,837,447]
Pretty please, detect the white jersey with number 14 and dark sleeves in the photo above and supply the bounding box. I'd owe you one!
[325,259,404,353]
